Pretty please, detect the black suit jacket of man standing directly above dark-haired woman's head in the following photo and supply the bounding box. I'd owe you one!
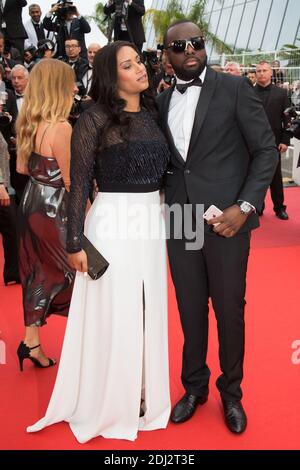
[104,0,146,45]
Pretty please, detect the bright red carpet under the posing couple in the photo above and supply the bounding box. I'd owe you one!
[0,188,300,450]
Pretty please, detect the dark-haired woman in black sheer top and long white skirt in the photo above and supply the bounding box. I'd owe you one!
[27,41,170,443]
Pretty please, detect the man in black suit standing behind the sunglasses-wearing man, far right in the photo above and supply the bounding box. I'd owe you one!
[254,61,290,220]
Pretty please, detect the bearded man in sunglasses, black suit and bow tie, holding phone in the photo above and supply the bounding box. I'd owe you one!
[158,20,277,433]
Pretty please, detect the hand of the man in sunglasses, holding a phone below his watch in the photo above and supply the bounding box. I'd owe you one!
[207,204,248,238]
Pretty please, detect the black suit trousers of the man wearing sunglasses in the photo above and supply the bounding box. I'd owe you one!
[168,232,250,400]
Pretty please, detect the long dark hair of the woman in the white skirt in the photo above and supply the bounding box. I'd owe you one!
[89,41,158,150]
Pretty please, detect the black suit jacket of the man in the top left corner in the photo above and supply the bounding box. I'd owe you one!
[3,0,27,39]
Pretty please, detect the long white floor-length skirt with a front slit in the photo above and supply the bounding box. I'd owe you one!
[27,191,170,443]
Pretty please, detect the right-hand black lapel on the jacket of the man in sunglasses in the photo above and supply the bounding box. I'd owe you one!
[187,67,218,162]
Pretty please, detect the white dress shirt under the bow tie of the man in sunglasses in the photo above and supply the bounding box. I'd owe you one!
[168,67,206,160]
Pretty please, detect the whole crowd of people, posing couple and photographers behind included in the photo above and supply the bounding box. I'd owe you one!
[0,0,298,442]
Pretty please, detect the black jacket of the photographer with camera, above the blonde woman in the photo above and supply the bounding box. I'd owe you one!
[43,16,91,57]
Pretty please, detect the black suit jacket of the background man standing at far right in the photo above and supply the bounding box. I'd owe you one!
[254,85,290,145]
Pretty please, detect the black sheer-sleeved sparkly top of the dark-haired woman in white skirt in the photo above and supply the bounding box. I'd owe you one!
[67,105,169,253]
